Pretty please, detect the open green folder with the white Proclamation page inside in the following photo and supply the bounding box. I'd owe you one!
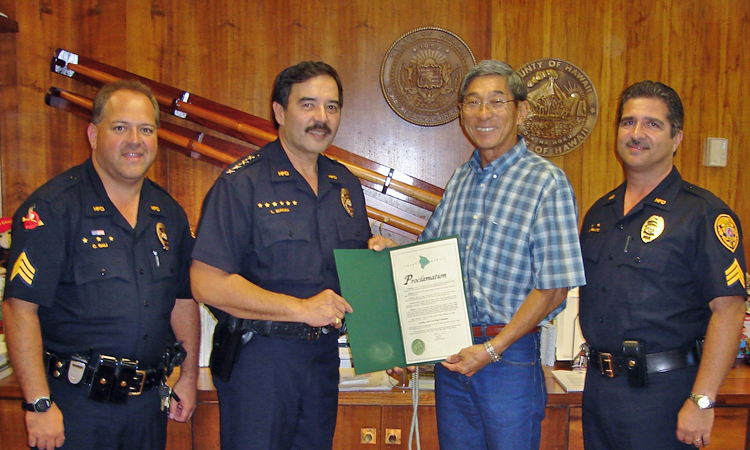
[333,236,473,374]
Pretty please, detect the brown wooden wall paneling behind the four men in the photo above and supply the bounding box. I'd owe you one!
[0,0,750,256]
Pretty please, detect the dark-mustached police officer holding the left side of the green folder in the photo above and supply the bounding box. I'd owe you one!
[191,62,370,449]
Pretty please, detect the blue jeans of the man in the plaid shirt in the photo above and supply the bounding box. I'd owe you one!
[435,333,547,450]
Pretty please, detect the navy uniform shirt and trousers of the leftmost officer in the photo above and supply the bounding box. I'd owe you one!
[6,160,192,448]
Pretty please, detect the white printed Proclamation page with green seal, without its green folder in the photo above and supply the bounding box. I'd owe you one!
[390,238,473,364]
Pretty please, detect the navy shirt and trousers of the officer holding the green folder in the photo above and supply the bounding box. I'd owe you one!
[193,141,370,448]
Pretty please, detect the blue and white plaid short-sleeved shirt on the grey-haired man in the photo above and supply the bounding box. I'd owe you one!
[419,136,586,324]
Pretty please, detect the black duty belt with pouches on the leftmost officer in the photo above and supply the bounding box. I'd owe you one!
[44,351,165,396]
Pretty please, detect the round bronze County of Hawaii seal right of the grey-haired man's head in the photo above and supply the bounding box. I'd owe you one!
[518,58,599,158]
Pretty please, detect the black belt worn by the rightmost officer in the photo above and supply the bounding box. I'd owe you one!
[589,345,700,378]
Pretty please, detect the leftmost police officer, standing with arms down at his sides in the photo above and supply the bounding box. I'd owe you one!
[2,81,200,450]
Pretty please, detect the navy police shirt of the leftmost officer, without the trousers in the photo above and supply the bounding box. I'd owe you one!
[5,159,193,367]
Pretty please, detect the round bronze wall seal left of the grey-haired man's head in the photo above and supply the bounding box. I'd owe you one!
[380,27,476,127]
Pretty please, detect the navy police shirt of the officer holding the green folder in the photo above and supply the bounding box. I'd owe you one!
[193,140,371,298]
